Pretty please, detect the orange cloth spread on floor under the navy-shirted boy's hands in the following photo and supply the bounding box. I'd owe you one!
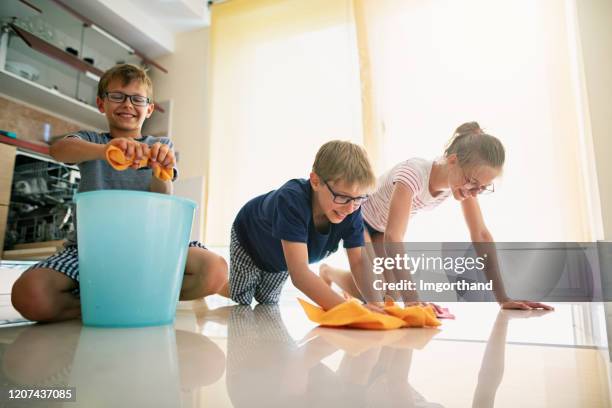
[298,299,440,330]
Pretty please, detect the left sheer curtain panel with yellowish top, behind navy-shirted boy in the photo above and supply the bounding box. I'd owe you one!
[206,0,363,245]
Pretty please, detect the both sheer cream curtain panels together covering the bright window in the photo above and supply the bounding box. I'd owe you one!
[206,0,594,245]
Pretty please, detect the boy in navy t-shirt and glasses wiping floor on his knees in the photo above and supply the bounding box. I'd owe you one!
[222,141,376,310]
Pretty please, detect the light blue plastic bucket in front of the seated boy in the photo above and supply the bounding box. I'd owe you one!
[75,190,196,327]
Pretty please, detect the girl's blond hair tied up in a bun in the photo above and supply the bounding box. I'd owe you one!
[444,122,506,169]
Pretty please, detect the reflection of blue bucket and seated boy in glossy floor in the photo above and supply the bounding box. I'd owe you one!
[2,321,225,407]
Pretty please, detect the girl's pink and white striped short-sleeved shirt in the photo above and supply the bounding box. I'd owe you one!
[361,158,451,232]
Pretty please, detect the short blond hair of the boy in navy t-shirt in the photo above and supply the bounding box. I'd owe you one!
[312,140,376,188]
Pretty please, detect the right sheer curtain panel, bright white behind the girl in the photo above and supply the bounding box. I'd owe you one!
[355,0,593,241]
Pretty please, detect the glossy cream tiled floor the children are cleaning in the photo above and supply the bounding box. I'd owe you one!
[0,290,610,408]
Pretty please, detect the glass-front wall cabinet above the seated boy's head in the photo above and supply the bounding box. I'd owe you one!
[0,0,167,129]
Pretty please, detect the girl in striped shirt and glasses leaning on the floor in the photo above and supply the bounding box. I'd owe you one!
[320,122,552,310]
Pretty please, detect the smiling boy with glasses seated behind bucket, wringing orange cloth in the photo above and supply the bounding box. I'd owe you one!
[11,64,227,321]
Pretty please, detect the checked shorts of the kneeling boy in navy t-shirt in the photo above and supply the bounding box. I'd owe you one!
[229,227,289,305]
